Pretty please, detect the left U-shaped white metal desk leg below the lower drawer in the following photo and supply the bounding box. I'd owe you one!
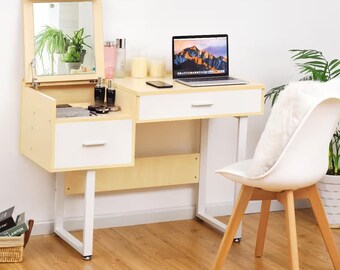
[54,171,96,260]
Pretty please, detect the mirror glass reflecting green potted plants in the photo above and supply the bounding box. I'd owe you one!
[33,2,95,76]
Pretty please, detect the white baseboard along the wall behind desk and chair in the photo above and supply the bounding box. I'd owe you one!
[32,200,309,235]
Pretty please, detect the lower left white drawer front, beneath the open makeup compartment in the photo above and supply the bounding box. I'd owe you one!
[54,119,133,169]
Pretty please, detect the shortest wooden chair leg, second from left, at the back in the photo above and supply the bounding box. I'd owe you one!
[255,200,271,257]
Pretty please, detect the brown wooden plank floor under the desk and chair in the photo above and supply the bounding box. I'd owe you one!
[0,209,340,270]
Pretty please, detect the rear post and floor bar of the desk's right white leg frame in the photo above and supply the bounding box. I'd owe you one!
[196,119,227,232]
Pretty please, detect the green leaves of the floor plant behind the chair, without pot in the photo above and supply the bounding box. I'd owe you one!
[264,49,340,175]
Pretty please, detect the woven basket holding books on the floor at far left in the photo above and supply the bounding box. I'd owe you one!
[0,234,24,263]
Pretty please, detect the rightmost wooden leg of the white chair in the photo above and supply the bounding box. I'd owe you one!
[306,185,340,270]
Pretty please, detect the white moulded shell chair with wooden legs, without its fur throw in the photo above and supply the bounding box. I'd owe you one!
[214,98,340,270]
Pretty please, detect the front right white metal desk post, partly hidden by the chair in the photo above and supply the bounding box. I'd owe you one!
[234,116,248,242]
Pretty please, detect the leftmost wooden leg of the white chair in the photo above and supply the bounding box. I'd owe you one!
[213,185,254,270]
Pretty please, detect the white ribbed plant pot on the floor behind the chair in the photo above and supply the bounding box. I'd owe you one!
[318,175,340,228]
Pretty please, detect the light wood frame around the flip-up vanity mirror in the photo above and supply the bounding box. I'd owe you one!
[22,0,104,83]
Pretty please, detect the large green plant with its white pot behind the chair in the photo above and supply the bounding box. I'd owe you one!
[265,50,340,228]
